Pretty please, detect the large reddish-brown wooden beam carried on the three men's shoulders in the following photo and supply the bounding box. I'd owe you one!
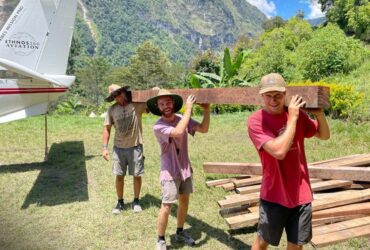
[132,86,330,108]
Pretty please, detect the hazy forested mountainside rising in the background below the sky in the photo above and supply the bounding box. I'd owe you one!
[77,0,267,65]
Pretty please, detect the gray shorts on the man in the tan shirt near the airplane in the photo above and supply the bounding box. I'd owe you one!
[112,144,145,176]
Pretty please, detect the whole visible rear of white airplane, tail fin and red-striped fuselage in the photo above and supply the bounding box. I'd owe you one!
[0,0,77,123]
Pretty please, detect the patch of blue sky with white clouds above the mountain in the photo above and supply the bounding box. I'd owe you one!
[246,0,324,20]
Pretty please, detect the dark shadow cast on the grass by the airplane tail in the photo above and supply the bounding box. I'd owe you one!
[0,141,89,209]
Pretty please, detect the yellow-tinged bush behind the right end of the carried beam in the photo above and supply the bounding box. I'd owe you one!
[289,81,364,121]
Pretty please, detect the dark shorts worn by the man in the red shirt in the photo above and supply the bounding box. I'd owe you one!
[258,199,312,246]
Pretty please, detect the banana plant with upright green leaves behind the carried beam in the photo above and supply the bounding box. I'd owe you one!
[189,48,250,88]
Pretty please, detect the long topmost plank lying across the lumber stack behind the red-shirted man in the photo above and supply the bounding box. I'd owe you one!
[203,162,370,181]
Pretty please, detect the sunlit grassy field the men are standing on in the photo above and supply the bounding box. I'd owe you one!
[0,113,370,250]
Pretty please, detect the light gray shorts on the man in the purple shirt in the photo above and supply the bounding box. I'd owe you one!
[161,177,193,204]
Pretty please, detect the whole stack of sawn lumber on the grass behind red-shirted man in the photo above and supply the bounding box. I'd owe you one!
[203,154,370,247]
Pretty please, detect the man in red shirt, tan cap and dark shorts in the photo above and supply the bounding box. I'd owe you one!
[248,73,330,249]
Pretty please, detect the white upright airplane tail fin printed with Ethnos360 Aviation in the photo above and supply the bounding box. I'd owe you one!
[0,0,77,75]
